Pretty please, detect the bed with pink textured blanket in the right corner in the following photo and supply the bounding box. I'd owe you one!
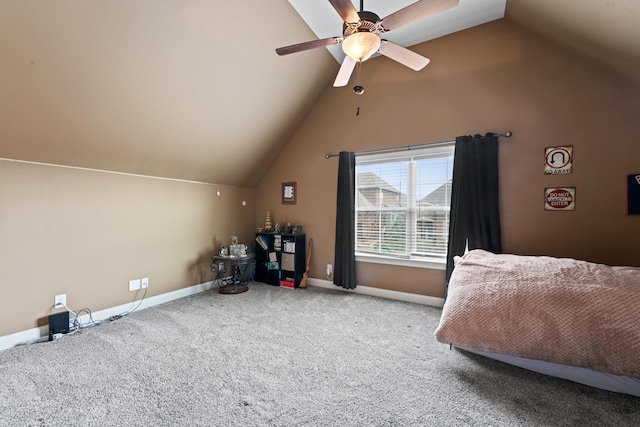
[435,249,640,396]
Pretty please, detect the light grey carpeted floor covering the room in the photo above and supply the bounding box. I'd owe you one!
[0,283,640,426]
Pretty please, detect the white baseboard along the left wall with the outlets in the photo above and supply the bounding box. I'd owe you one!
[0,282,213,351]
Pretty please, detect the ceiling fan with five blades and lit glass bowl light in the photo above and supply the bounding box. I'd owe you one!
[276,0,460,87]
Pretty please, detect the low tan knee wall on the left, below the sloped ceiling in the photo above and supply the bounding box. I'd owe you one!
[0,160,255,336]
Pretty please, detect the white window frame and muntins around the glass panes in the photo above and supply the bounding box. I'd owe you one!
[354,141,455,270]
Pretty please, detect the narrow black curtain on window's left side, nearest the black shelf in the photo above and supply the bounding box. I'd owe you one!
[333,151,356,289]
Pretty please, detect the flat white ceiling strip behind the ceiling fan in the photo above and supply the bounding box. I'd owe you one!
[289,0,507,63]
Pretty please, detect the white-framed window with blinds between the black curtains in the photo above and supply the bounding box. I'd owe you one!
[355,143,454,268]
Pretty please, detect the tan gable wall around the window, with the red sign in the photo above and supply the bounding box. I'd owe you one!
[256,20,640,297]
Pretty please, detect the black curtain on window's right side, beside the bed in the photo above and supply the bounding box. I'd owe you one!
[446,133,502,286]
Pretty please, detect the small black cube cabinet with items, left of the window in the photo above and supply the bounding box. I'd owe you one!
[255,233,306,288]
